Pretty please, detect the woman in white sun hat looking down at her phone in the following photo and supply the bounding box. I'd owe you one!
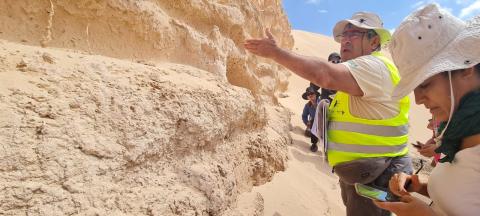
[375,5,480,216]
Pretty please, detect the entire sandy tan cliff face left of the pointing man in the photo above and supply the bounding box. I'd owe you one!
[0,0,293,215]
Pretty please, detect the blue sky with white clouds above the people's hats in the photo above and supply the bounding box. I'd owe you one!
[282,0,480,36]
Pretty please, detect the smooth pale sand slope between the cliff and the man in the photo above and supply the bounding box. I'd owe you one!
[238,30,345,216]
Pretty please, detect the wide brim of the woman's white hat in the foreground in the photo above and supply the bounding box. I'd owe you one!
[392,16,480,100]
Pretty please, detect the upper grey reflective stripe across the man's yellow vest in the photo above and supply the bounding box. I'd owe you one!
[328,122,408,137]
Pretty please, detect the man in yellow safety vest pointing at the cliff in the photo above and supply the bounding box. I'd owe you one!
[245,12,412,216]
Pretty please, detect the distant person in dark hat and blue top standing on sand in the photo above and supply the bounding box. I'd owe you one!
[302,87,319,152]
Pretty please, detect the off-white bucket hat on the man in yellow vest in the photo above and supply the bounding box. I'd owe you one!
[333,12,391,45]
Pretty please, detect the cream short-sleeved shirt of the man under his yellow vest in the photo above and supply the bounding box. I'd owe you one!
[341,55,400,119]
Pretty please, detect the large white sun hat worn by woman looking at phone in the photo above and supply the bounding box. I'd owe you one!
[389,4,480,99]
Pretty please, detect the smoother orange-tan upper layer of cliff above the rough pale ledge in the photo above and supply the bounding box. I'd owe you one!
[0,0,293,101]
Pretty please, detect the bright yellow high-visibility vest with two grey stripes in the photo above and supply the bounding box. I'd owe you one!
[327,52,410,166]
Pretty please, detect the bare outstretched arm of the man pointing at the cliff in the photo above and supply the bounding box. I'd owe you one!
[244,29,363,96]
